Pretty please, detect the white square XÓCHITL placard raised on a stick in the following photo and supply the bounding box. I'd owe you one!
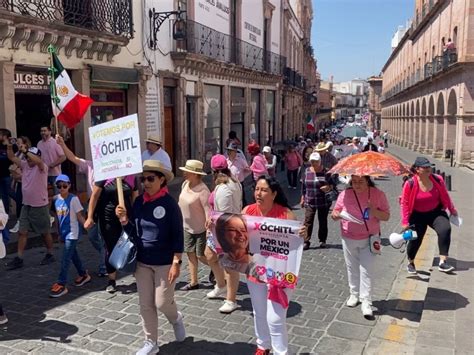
[89,114,142,181]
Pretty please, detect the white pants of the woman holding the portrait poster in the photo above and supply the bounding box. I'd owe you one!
[247,281,293,355]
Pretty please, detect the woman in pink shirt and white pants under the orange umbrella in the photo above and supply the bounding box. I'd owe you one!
[331,175,390,319]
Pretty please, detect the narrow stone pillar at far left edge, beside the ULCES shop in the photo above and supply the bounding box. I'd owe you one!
[0,62,17,137]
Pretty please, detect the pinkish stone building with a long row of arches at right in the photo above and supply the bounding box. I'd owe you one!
[381,0,474,166]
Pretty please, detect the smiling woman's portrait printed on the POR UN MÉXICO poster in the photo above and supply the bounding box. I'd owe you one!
[215,213,252,274]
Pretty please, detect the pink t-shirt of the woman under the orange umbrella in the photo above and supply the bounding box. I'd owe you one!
[334,187,390,240]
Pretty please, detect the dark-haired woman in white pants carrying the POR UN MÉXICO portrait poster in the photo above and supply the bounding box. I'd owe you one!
[242,176,306,355]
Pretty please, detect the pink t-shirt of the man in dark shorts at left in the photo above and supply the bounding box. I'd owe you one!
[20,160,49,207]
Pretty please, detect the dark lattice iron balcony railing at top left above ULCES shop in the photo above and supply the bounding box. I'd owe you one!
[0,0,133,38]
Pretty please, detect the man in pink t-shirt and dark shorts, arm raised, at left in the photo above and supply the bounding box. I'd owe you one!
[7,144,54,270]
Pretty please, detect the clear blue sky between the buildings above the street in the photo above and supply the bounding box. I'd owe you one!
[311,0,415,82]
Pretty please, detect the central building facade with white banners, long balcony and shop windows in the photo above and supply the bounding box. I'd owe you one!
[146,0,316,171]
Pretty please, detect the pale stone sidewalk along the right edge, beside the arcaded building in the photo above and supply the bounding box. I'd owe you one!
[378,145,474,354]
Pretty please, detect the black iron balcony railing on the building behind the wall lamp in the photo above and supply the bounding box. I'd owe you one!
[181,20,286,75]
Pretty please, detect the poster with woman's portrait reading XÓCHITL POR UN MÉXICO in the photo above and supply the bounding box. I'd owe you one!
[210,212,303,288]
